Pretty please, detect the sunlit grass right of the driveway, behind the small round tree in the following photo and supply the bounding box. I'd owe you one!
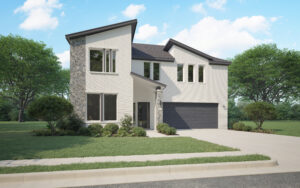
[244,121,300,136]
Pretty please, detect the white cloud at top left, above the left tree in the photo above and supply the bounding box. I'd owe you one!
[14,0,62,30]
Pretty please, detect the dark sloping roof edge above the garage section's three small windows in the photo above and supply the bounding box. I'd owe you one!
[164,39,231,65]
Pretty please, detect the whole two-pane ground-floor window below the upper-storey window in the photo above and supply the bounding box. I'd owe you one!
[87,94,117,121]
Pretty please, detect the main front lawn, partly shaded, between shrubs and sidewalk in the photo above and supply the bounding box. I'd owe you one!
[0,122,236,160]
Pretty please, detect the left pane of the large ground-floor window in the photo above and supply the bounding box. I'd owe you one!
[87,94,100,120]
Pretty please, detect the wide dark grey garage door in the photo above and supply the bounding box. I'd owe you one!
[163,102,218,129]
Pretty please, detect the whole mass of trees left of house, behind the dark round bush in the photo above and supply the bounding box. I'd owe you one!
[0,35,70,122]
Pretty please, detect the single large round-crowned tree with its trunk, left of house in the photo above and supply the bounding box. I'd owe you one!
[0,35,61,122]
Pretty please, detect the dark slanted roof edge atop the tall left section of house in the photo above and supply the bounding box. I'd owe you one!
[66,19,137,43]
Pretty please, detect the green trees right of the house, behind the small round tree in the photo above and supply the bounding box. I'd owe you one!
[228,44,300,124]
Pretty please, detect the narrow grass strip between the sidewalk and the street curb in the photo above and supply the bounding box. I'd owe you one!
[0,155,270,174]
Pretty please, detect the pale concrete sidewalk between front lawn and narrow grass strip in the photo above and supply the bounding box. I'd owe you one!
[0,151,254,167]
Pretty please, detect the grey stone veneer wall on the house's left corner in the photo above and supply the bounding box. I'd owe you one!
[70,37,86,121]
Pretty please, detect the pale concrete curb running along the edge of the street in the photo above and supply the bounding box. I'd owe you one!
[0,160,278,185]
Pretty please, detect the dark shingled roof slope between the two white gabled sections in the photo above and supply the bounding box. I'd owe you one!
[132,43,175,62]
